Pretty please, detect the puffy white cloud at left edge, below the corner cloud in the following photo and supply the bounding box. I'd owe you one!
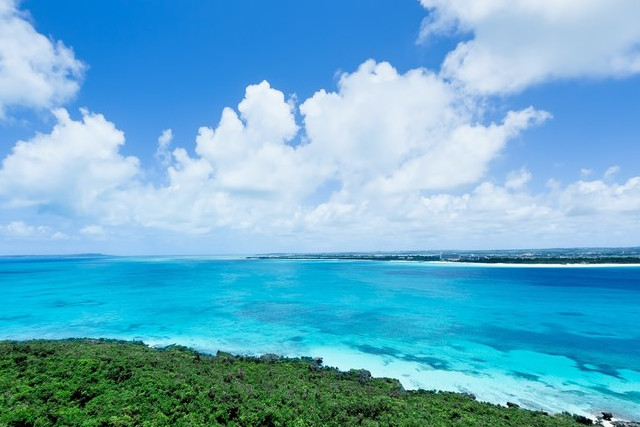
[0,109,138,216]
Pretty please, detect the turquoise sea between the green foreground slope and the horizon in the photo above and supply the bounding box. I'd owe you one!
[0,257,640,419]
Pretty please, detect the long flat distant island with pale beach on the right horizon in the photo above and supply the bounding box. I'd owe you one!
[247,247,640,264]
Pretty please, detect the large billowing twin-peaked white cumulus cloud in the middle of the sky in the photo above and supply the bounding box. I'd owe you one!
[131,61,548,233]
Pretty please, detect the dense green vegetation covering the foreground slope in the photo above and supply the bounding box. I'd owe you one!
[0,340,596,427]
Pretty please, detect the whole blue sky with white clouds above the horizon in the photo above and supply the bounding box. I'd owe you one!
[0,0,640,255]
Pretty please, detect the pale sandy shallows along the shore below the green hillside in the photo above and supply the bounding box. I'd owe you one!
[140,340,640,427]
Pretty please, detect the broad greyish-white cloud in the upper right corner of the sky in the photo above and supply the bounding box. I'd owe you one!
[420,0,640,94]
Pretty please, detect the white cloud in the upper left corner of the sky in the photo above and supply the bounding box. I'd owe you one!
[0,0,85,119]
